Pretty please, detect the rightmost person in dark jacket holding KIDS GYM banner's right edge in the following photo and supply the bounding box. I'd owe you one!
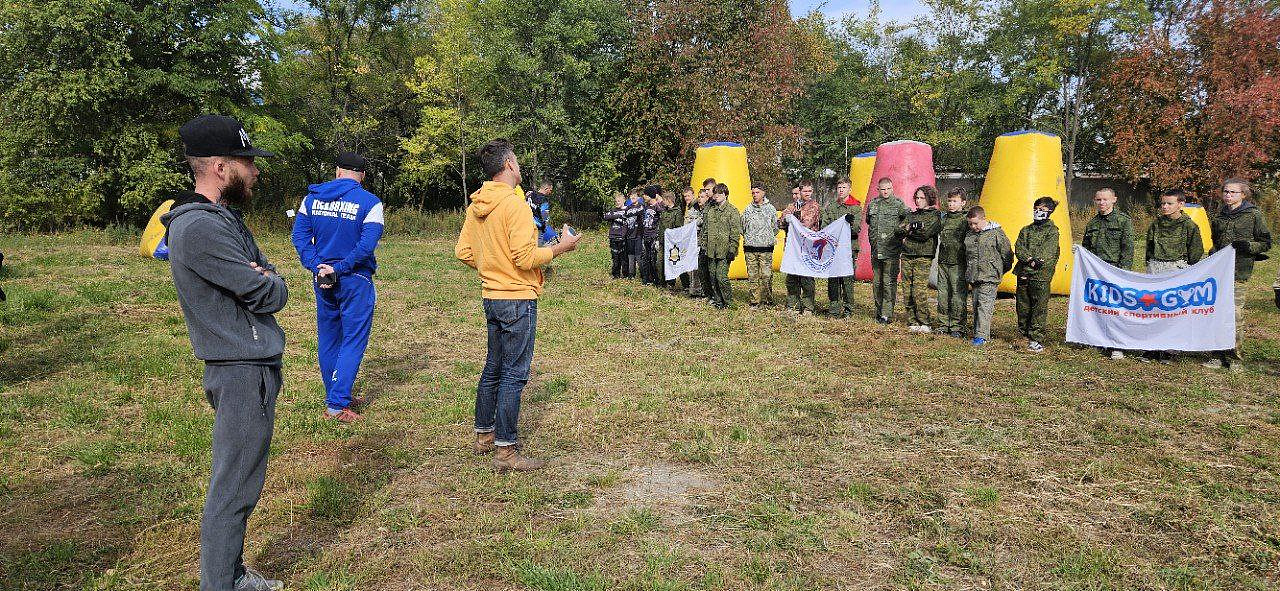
[1204,179,1280,371]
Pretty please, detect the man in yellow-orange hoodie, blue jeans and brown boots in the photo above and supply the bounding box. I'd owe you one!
[453,139,581,472]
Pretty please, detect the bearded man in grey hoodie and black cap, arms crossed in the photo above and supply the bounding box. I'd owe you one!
[160,115,289,591]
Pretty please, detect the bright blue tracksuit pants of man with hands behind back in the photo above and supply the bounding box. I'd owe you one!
[315,274,378,409]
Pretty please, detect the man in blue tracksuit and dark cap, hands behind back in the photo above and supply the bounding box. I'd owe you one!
[293,152,383,422]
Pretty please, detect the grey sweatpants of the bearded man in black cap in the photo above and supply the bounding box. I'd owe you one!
[200,365,280,591]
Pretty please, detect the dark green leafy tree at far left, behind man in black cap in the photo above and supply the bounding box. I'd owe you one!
[0,0,270,229]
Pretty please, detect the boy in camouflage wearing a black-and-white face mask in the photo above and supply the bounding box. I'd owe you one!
[1014,197,1060,353]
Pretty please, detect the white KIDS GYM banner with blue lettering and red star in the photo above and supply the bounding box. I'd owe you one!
[1066,248,1235,351]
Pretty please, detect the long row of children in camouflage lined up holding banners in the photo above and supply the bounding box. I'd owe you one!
[604,172,1280,370]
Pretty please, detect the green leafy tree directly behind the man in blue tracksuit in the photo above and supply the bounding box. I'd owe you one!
[262,0,431,206]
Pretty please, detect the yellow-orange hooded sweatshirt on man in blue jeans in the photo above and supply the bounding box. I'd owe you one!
[453,180,552,299]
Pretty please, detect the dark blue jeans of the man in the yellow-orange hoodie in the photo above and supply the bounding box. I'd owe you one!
[476,299,538,446]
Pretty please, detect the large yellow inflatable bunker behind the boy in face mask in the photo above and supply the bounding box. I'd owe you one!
[979,129,1074,296]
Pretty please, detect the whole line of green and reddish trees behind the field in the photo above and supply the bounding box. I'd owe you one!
[0,0,1280,230]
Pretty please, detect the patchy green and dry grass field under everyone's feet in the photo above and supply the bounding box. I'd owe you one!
[0,222,1280,591]
